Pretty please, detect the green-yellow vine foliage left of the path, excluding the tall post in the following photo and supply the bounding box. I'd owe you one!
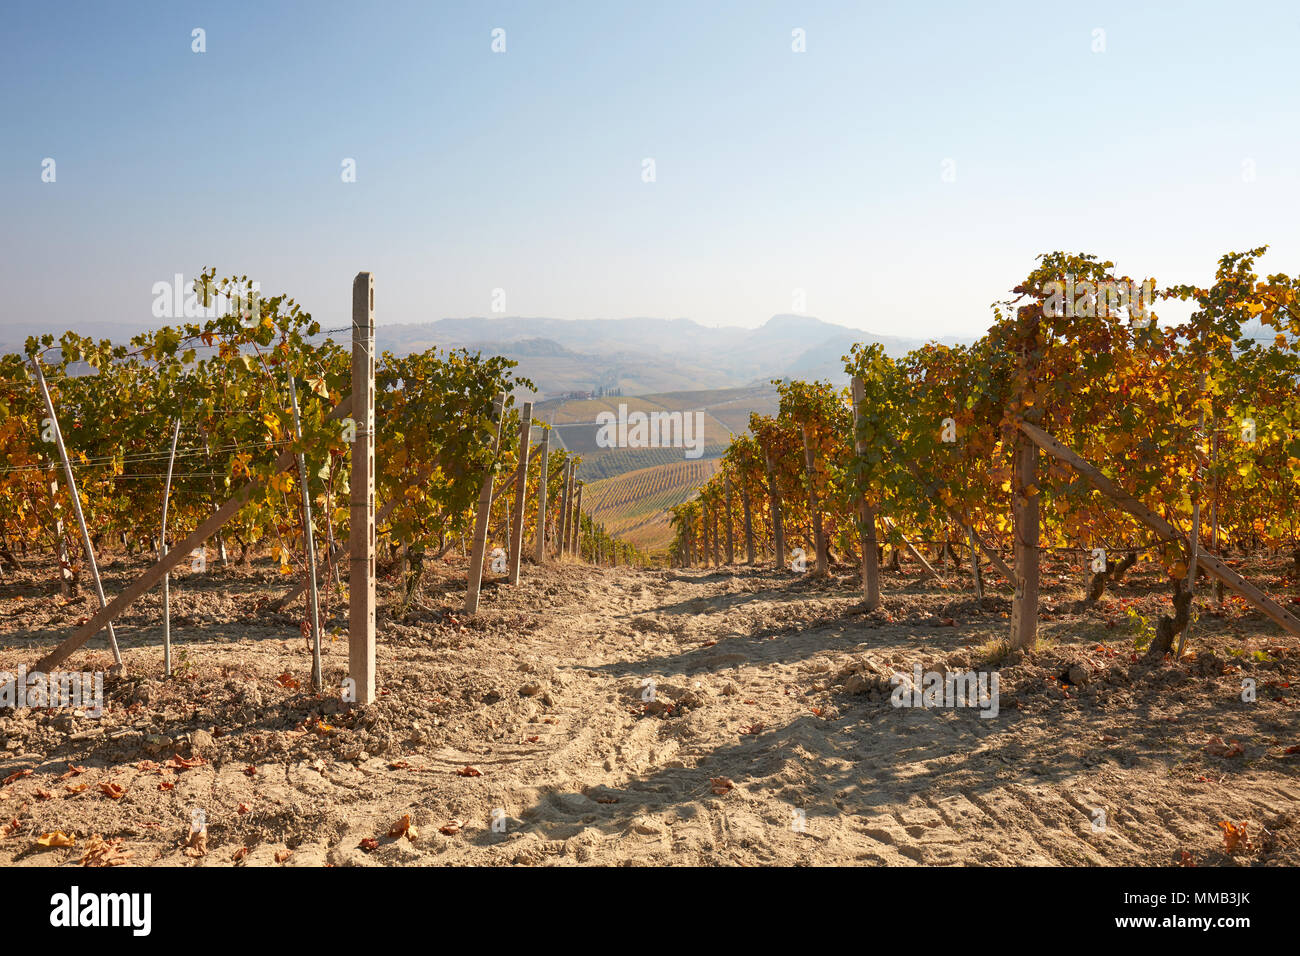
[0,271,641,616]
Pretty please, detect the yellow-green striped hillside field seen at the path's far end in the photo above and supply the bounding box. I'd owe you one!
[585,458,718,553]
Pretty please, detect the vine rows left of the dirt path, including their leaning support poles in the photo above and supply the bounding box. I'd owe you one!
[0,271,638,686]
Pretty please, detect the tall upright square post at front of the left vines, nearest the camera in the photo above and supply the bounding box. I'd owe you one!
[351,272,376,704]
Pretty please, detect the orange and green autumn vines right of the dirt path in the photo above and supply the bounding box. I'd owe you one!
[672,248,1300,661]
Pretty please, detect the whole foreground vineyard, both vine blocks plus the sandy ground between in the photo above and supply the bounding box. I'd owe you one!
[0,250,1300,866]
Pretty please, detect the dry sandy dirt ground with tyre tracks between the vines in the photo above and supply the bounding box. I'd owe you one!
[0,567,1300,865]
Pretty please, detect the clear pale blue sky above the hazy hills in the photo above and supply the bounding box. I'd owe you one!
[0,0,1300,336]
